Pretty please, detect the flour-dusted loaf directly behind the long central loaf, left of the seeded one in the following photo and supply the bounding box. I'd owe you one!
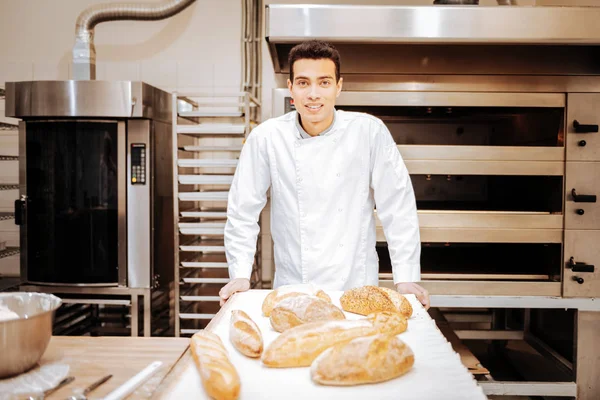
[270,295,346,332]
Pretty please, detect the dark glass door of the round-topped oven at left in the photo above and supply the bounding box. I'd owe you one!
[15,119,127,286]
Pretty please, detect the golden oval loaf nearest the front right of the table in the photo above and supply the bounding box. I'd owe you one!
[310,334,415,386]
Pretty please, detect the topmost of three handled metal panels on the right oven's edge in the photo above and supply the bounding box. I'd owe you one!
[566,93,600,161]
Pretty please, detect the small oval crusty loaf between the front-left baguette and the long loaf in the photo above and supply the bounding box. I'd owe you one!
[229,310,263,358]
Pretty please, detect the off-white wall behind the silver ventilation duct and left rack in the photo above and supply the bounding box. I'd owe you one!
[0,0,242,275]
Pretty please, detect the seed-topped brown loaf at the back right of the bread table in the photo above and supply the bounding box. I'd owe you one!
[340,285,413,318]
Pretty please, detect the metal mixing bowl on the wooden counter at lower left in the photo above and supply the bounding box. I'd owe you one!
[0,292,62,379]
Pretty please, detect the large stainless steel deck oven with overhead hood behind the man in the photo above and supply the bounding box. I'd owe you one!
[262,4,600,399]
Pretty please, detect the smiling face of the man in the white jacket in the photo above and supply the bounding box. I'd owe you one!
[288,58,342,136]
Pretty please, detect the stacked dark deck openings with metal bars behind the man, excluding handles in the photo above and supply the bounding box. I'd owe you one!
[273,89,566,296]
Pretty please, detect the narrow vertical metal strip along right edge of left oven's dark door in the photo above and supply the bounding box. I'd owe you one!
[117,121,127,286]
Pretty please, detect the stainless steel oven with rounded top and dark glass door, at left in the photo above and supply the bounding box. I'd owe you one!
[6,81,174,288]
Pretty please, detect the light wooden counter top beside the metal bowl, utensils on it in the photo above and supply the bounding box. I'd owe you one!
[34,336,189,400]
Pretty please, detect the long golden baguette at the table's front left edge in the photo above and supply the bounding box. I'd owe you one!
[190,330,241,400]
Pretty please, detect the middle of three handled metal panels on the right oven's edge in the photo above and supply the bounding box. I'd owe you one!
[565,162,600,229]
